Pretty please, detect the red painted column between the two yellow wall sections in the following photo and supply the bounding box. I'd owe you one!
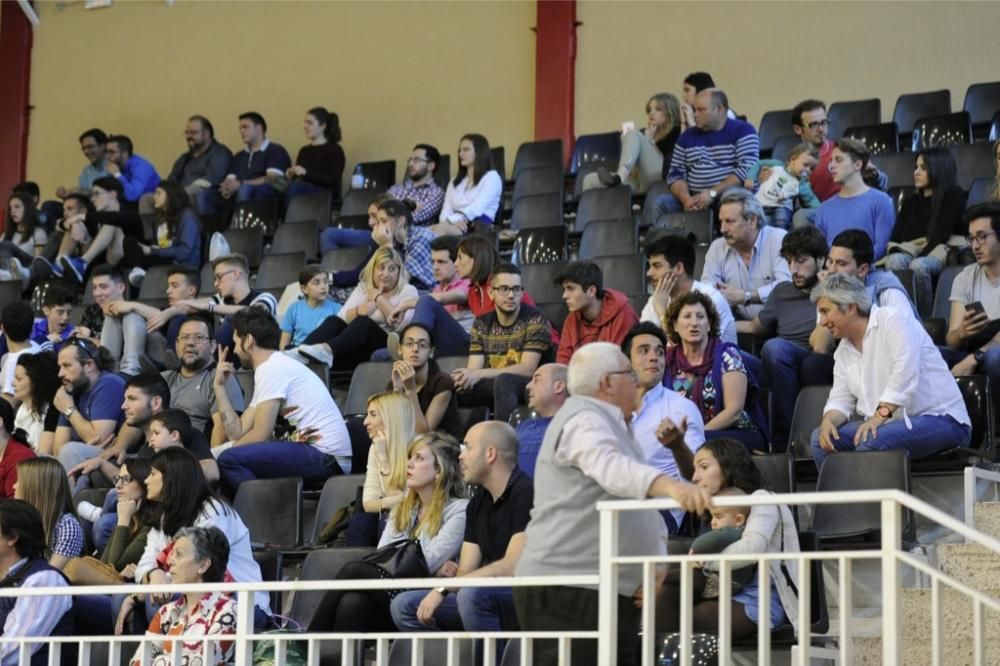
[535,0,576,162]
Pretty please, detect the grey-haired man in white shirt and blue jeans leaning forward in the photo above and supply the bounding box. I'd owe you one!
[811,273,972,467]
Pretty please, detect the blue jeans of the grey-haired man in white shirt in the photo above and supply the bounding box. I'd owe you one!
[812,416,972,469]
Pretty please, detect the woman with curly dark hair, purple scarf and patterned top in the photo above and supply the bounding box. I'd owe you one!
[663,291,767,450]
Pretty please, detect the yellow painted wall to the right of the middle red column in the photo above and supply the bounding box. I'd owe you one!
[576,1,1000,134]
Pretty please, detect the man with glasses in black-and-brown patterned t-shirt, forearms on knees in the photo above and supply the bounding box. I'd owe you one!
[451,263,552,421]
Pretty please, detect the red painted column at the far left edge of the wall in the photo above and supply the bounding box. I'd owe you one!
[0,2,32,231]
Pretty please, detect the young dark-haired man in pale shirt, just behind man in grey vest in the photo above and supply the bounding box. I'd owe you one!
[622,322,705,534]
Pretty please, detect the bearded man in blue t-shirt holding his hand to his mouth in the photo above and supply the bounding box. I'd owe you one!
[52,337,125,469]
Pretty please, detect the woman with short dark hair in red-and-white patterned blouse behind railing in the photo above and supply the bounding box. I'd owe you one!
[122,527,236,666]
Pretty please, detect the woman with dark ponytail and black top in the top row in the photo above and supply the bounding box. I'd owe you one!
[285,106,347,204]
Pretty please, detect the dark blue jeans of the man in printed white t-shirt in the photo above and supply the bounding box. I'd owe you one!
[217,441,350,494]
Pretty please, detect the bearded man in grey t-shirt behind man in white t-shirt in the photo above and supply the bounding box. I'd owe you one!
[162,315,243,444]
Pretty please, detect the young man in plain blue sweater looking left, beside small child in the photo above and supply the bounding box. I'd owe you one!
[816,139,896,261]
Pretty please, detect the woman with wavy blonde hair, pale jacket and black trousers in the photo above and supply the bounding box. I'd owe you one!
[308,432,469,633]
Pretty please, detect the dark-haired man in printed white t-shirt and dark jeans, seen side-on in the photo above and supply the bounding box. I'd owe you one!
[214,308,351,494]
